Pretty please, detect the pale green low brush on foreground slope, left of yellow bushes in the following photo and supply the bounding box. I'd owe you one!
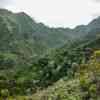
[31,79,81,100]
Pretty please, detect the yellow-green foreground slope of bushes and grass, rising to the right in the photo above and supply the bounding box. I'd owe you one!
[1,51,100,100]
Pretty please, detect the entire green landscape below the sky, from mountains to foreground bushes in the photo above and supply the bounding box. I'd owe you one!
[0,9,100,100]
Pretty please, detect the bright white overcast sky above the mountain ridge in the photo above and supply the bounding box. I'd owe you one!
[0,0,100,28]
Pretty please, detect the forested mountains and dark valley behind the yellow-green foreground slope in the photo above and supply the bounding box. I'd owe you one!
[0,9,100,95]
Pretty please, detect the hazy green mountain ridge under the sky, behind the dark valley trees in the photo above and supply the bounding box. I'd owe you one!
[0,9,100,72]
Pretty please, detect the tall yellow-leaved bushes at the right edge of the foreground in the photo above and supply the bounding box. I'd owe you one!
[79,50,100,100]
